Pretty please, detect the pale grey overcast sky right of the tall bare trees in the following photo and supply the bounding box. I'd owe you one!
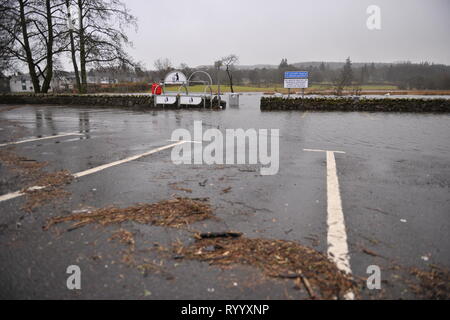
[123,0,450,69]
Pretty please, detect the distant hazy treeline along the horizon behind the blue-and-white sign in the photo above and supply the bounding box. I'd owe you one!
[141,54,450,95]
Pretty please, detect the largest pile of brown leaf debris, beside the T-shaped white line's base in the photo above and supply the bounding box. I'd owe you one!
[173,233,357,299]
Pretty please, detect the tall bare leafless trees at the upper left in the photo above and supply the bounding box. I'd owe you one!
[0,0,137,93]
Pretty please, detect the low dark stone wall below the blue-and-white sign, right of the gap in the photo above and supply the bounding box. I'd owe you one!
[261,97,450,113]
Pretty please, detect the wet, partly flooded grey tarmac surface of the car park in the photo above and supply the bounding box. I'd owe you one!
[0,94,450,299]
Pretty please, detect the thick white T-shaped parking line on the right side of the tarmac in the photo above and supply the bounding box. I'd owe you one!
[303,149,355,300]
